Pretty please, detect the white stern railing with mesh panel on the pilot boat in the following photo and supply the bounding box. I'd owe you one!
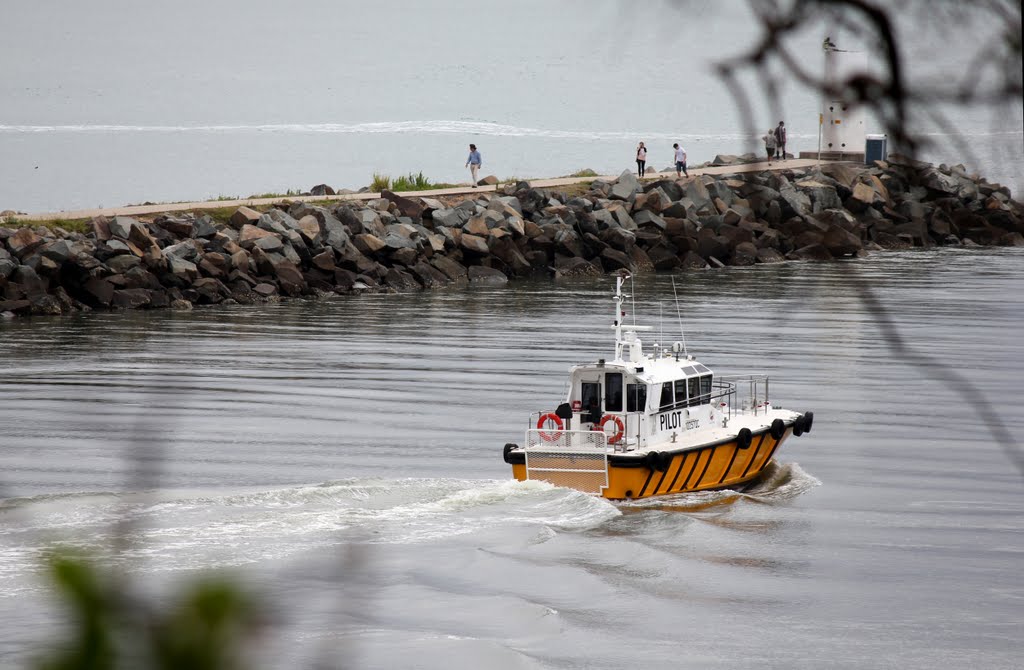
[524,428,608,495]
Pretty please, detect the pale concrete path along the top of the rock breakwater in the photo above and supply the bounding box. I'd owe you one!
[15,158,835,221]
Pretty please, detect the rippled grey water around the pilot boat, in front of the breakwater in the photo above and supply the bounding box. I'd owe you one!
[0,249,1024,670]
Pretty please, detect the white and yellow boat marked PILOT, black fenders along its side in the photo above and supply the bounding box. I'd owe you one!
[504,275,814,500]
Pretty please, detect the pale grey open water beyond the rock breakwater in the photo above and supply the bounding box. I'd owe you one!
[0,0,1024,212]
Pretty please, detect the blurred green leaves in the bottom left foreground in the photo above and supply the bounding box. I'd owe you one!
[35,552,259,670]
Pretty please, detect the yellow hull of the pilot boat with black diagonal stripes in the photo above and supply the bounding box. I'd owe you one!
[512,427,793,500]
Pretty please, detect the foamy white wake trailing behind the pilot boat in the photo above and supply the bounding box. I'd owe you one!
[0,478,621,590]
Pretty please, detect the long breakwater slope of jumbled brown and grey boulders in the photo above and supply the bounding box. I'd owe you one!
[0,156,1024,316]
